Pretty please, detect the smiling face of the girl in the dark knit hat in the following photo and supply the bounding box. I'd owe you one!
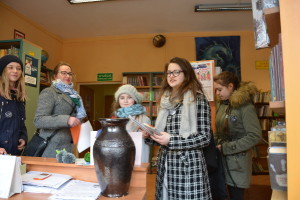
[4,62,22,87]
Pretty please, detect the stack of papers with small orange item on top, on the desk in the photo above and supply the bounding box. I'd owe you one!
[22,171,72,193]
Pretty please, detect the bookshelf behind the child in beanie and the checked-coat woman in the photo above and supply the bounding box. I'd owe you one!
[123,72,163,173]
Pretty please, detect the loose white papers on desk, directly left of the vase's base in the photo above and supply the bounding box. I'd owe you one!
[49,180,101,200]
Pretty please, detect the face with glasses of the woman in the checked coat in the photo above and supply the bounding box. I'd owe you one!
[167,63,184,90]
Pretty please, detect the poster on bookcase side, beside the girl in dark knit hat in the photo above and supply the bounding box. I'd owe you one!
[24,55,38,87]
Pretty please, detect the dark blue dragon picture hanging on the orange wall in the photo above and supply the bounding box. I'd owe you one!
[195,36,241,80]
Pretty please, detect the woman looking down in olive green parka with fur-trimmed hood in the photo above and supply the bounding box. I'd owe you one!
[214,72,262,200]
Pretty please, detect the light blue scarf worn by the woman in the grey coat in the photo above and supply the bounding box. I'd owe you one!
[52,79,86,119]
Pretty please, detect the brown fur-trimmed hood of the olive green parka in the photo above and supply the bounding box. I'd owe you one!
[229,82,258,108]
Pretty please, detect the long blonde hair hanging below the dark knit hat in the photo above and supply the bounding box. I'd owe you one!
[0,67,26,101]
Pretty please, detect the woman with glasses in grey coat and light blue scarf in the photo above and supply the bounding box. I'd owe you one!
[34,62,86,158]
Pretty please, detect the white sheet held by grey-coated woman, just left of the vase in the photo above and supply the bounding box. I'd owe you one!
[77,121,93,153]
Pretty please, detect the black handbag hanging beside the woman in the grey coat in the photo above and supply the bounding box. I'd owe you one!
[22,129,57,157]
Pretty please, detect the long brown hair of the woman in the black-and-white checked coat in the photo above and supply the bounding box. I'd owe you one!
[159,57,203,102]
